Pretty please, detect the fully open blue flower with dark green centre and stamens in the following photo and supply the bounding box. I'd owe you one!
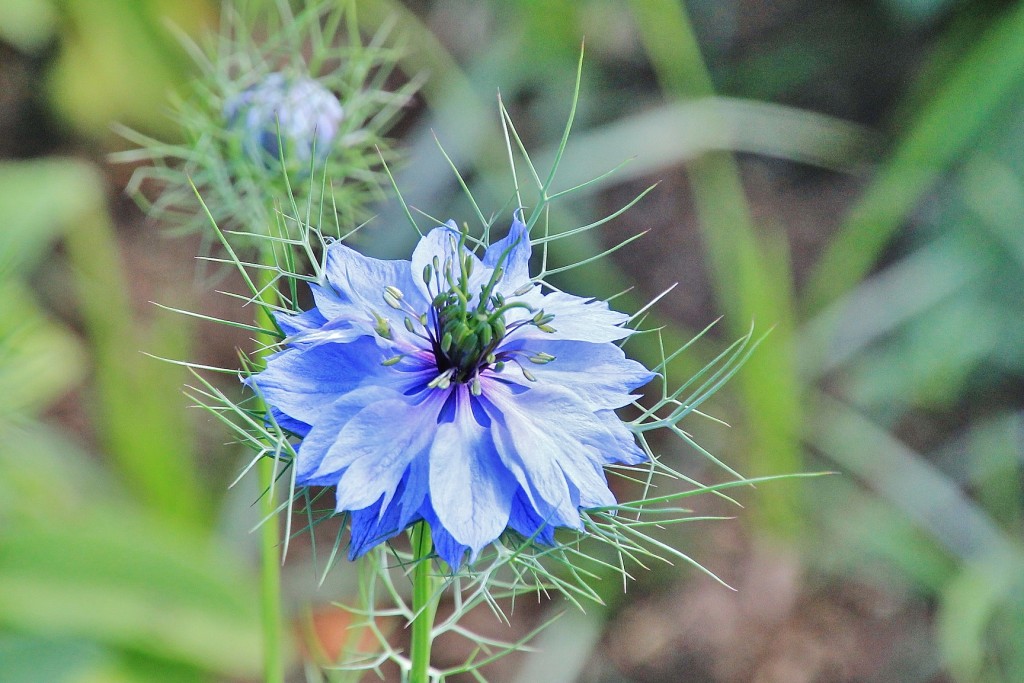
[248,218,653,567]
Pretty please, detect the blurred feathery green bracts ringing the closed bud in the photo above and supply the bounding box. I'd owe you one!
[113,0,417,253]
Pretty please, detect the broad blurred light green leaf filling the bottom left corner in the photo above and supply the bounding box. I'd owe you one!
[0,425,260,680]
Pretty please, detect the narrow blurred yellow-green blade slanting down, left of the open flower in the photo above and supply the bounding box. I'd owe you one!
[65,192,210,526]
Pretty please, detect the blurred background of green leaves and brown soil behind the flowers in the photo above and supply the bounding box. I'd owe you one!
[0,0,1024,683]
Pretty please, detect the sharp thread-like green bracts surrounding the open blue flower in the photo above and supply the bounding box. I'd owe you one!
[161,54,806,681]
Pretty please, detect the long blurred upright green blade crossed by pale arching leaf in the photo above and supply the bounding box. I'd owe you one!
[630,0,803,533]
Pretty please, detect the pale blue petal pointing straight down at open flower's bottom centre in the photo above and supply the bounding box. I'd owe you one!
[430,385,517,562]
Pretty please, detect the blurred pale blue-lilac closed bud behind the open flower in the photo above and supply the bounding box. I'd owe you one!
[224,73,345,171]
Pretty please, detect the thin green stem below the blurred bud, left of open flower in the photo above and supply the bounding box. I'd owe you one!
[256,259,285,683]
